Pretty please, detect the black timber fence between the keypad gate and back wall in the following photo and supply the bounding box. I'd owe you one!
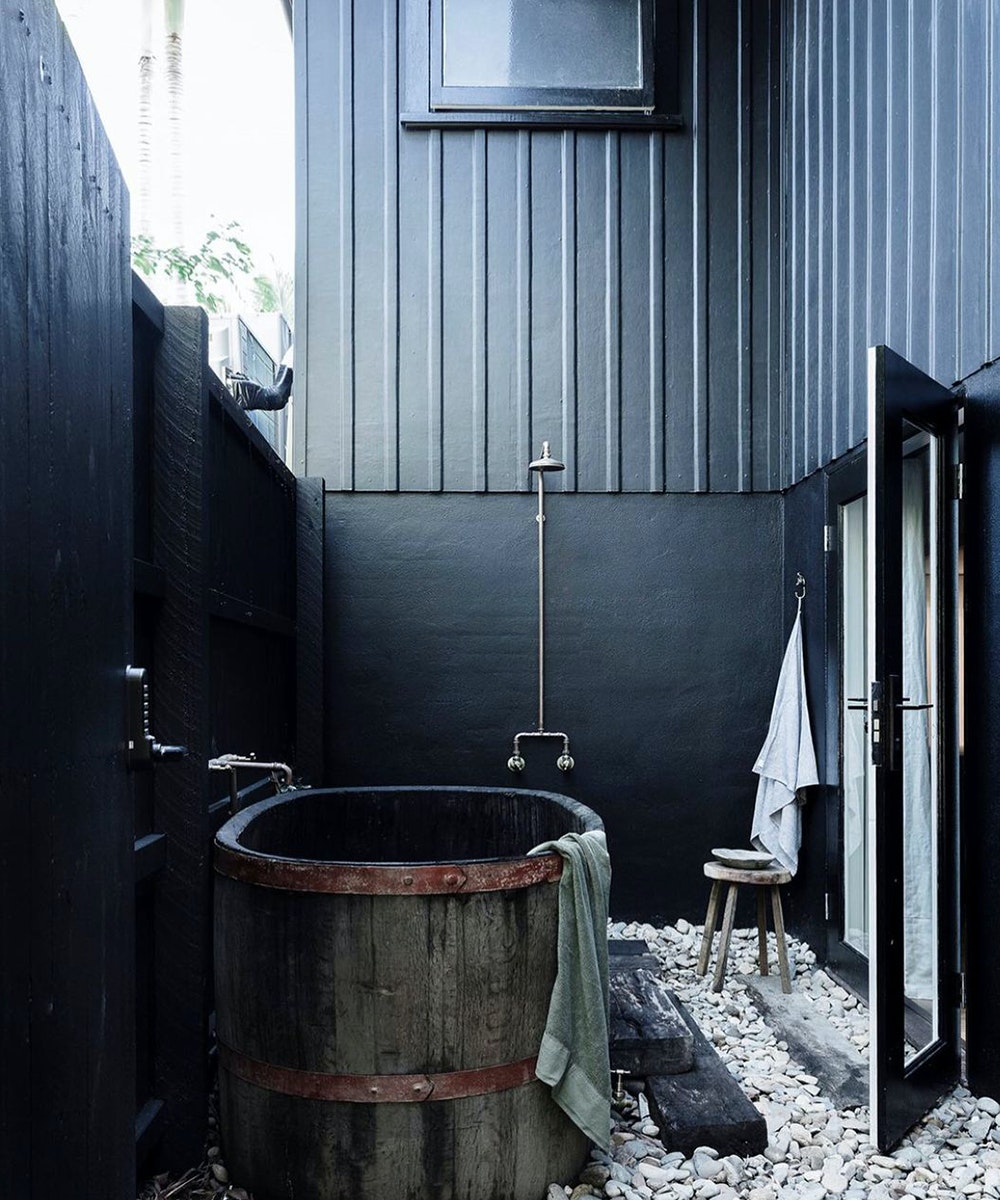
[132,276,323,1177]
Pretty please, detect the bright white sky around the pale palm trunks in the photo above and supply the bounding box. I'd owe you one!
[58,0,294,272]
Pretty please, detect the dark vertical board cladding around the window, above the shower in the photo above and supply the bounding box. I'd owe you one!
[295,0,782,492]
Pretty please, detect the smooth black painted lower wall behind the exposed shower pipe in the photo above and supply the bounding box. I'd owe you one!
[325,494,794,920]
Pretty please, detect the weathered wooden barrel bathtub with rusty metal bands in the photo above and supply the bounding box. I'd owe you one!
[215,787,601,1200]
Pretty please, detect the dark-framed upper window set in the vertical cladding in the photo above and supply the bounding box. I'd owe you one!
[401,0,679,126]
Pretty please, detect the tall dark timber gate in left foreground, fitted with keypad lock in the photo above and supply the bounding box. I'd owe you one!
[0,0,136,1196]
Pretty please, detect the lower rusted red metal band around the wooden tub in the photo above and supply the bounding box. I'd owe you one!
[218,1042,538,1104]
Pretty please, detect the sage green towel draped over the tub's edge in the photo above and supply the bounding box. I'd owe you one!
[529,830,611,1150]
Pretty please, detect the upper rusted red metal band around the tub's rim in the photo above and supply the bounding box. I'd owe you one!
[215,842,563,896]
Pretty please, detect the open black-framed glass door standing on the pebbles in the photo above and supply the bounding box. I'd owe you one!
[864,347,959,1151]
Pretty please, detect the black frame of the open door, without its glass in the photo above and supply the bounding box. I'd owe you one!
[868,346,962,1151]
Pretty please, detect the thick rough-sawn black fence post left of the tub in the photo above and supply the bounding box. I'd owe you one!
[152,307,214,1163]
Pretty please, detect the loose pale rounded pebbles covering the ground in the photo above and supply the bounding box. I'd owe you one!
[140,920,1000,1200]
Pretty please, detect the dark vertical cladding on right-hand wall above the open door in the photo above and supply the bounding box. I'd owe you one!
[782,0,1000,486]
